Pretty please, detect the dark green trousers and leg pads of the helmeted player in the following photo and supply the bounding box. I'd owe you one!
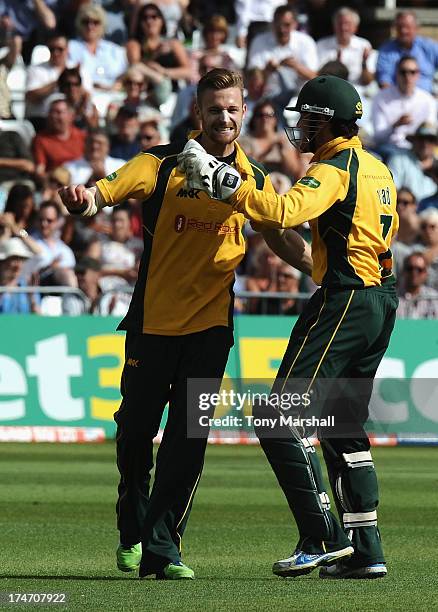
[255,285,398,567]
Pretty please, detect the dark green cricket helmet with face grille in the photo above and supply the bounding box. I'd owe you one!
[285,75,363,151]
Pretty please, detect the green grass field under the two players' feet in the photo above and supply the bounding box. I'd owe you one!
[0,443,438,612]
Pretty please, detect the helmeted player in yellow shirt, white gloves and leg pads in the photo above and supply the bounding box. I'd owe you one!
[180,76,398,578]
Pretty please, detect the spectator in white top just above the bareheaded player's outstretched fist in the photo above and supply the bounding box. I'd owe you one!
[64,128,125,187]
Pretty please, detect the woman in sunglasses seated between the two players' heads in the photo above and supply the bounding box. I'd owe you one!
[239,100,304,182]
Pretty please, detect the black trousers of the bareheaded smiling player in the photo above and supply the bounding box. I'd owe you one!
[114,327,233,573]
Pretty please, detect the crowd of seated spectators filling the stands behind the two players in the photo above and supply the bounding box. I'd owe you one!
[0,0,438,318]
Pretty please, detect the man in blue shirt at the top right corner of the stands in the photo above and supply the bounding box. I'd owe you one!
[376,11,438,92]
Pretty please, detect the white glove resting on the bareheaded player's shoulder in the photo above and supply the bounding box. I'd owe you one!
[178,139,242,200]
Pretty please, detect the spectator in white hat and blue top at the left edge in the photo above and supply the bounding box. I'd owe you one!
[0,238,40,314]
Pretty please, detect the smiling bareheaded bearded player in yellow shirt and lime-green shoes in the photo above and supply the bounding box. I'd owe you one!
[60,69,311,580]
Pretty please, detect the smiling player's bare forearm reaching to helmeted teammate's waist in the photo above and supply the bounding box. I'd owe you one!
[262,229,313,276]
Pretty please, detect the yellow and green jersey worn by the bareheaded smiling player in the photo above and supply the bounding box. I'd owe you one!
[97,135,274,336]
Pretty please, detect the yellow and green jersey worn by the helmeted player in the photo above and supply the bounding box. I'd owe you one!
[230,137,398,288]
